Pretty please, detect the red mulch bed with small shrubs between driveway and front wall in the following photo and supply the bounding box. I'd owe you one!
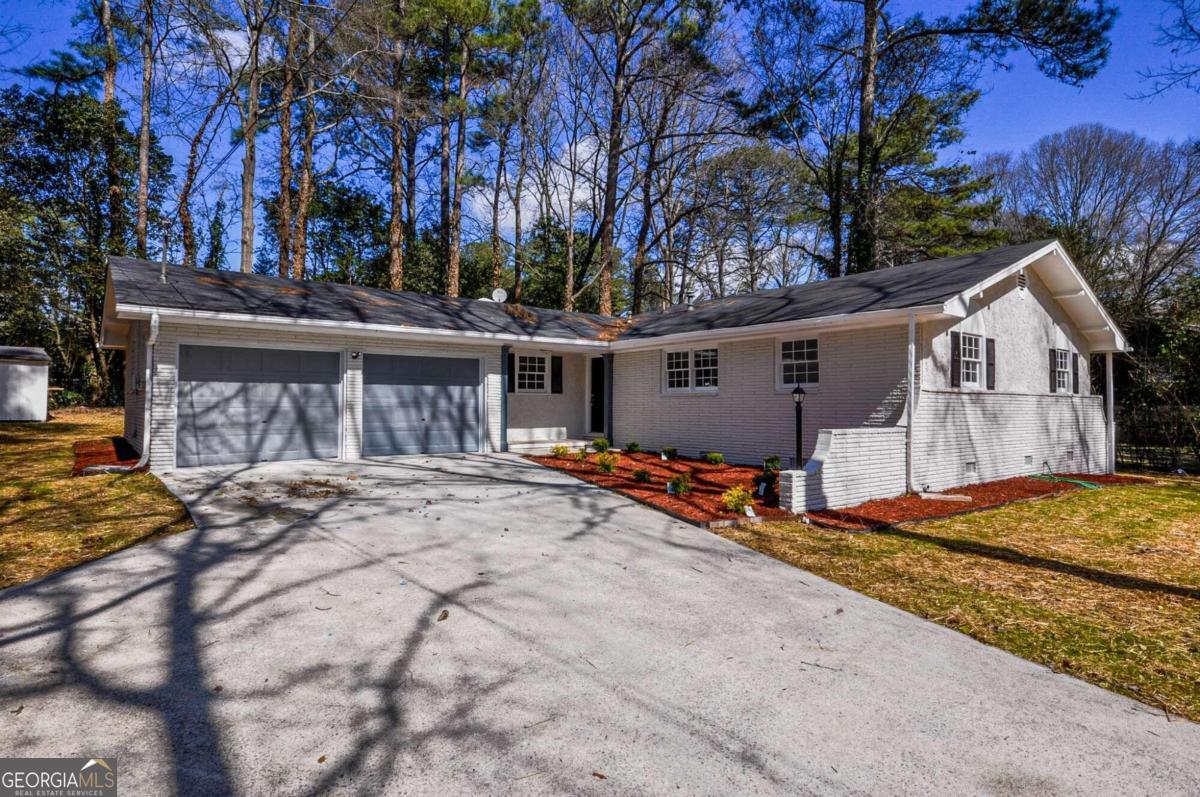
[528,451,791,523]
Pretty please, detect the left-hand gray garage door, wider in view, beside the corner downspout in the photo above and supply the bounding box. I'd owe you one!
[175,346,342,467]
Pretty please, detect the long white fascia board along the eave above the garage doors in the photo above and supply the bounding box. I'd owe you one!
[116,305,608,352]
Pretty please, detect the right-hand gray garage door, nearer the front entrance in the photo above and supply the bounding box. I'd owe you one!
[362,354,481,456]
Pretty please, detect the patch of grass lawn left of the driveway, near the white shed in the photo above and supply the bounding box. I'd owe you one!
[0,409,192,587]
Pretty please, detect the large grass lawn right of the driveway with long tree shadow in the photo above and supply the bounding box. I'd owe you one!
[714,478,1200,721]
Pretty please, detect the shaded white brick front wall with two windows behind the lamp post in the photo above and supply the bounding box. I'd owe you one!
[613,325,908,465]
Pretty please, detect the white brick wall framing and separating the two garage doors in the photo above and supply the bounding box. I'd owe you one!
[150,322,504,471]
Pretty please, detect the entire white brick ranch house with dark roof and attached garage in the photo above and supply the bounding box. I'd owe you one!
[104,241,1126,511]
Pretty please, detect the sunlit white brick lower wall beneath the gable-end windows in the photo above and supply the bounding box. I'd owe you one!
[912,390,1106,491]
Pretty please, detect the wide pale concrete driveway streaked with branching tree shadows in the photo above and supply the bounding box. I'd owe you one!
[0,456,1200,796]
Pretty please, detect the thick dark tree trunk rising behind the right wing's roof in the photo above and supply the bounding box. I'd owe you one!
[847,0,880,274]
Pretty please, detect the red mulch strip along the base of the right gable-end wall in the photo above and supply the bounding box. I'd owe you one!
[806,473,1145,531]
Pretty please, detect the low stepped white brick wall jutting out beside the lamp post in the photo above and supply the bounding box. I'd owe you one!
[779,426,906,513]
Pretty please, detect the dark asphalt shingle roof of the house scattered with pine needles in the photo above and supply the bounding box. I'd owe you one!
[109,241,1050,341]
